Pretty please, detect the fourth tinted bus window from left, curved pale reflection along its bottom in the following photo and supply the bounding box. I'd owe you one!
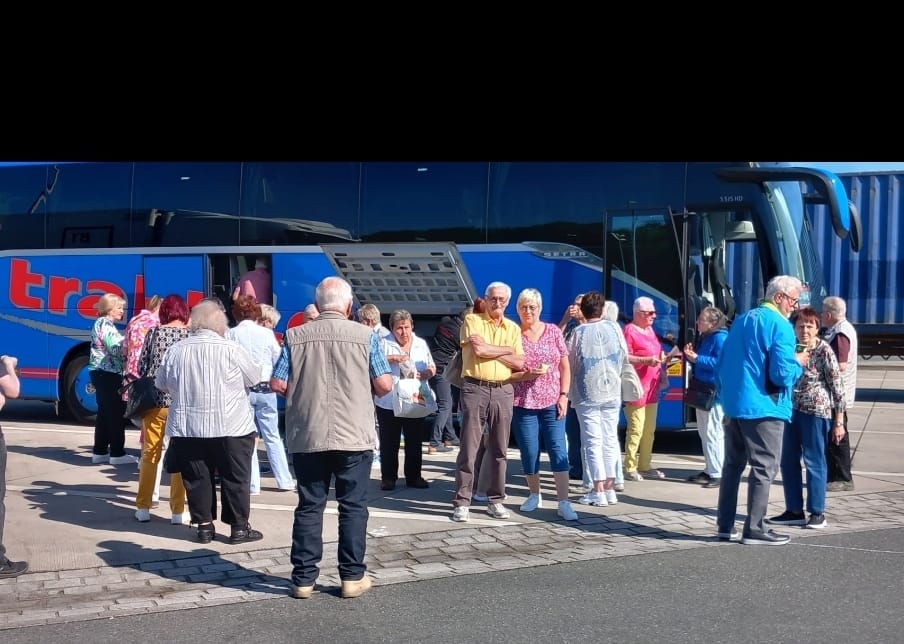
[240,163,360,246]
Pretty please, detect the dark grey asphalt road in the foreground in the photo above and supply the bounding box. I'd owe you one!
[3,528,904,644]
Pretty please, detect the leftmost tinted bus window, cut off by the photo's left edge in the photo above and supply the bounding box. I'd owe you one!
[0,165,47,249]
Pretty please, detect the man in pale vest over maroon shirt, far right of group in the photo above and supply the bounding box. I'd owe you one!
[822,295,858,492]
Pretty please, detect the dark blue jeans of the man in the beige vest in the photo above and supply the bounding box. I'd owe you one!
[290,450,374,586]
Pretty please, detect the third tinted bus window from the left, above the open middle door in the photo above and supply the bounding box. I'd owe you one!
[132,162,241,246]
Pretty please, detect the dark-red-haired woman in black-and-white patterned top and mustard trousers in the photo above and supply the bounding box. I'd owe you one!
[135,294,191,525]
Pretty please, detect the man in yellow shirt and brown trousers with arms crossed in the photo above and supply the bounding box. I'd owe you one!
[452,282,524,521]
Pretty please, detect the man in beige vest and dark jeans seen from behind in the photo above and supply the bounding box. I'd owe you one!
[270,277,392,599]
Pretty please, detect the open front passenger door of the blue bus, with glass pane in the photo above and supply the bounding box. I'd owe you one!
[603,208,693,430]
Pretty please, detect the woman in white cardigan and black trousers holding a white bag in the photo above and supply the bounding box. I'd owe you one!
[374,309,436,490]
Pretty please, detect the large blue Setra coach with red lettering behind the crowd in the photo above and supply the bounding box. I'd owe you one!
[0,162,859,430]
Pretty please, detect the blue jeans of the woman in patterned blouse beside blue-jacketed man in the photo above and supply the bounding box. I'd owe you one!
[781,409,832,514]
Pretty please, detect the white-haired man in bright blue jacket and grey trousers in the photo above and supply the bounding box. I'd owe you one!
[716,275,805,546]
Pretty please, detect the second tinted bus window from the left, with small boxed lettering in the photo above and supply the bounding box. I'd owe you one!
[47,163,132,248]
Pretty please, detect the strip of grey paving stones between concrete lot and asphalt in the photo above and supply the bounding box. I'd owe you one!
[0,491,904,630]
